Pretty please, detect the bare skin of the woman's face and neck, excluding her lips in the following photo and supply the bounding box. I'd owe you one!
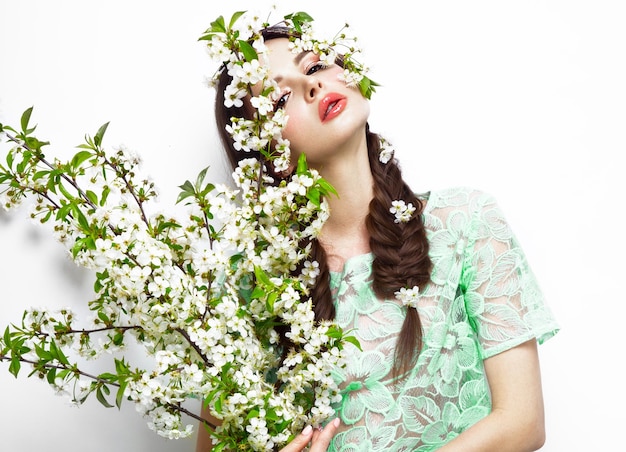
[254,39,373,271]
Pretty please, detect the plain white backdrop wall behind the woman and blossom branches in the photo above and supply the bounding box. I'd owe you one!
[0,0,626,452]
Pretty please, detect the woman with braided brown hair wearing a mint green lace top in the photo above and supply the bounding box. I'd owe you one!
[198,23,558,452]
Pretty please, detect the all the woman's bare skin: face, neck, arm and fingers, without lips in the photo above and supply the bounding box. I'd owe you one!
[197,39,545,452]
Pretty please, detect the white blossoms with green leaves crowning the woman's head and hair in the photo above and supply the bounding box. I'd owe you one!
[201,12,378,172]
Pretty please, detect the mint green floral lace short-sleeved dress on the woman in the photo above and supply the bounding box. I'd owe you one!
[329,188,559,452]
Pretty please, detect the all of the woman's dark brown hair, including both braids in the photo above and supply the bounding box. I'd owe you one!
[215,27,431,376]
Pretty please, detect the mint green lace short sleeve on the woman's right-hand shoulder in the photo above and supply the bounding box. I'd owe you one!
[461,194,559,358]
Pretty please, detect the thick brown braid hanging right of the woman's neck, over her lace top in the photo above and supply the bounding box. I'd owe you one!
[365,128,431,375]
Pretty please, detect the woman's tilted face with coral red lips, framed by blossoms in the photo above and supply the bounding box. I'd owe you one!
[254,38,369,167]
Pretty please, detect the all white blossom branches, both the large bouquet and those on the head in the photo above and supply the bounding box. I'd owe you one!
[0,8,366,450]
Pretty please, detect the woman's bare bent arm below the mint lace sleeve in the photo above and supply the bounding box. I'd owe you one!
[439,339,545,452]
